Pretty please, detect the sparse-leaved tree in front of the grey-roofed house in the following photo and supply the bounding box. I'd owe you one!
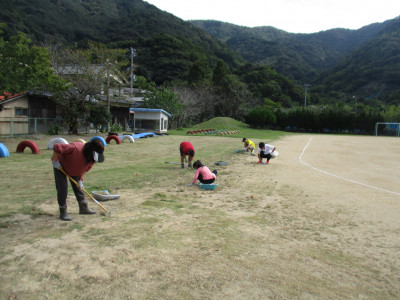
[49,44,123,134]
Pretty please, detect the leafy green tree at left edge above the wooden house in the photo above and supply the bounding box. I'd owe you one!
[0,24,65,95]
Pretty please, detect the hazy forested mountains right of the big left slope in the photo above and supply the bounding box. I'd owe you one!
[192,18,400,104]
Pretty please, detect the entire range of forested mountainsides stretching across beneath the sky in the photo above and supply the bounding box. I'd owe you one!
[0,0,400,114]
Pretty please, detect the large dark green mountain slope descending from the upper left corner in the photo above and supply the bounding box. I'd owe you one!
[0,0,245,84]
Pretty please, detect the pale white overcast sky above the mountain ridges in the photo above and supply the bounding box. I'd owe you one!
[145,0,400,33]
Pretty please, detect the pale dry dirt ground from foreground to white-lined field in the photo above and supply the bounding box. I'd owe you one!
[0,135,400,299]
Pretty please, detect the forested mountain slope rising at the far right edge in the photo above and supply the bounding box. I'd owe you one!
[317,18,400,103]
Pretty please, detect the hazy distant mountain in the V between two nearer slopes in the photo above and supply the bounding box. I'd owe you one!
[191,20,388,83]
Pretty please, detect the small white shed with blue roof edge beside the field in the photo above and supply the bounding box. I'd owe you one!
[129,108,171,133]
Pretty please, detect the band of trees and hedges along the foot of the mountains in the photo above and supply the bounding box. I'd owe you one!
[0,25,400,133]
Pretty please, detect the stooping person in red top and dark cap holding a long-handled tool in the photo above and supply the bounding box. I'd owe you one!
[51,139,104,221]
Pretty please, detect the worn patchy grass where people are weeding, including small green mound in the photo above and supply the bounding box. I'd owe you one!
[0,118,394,299]
